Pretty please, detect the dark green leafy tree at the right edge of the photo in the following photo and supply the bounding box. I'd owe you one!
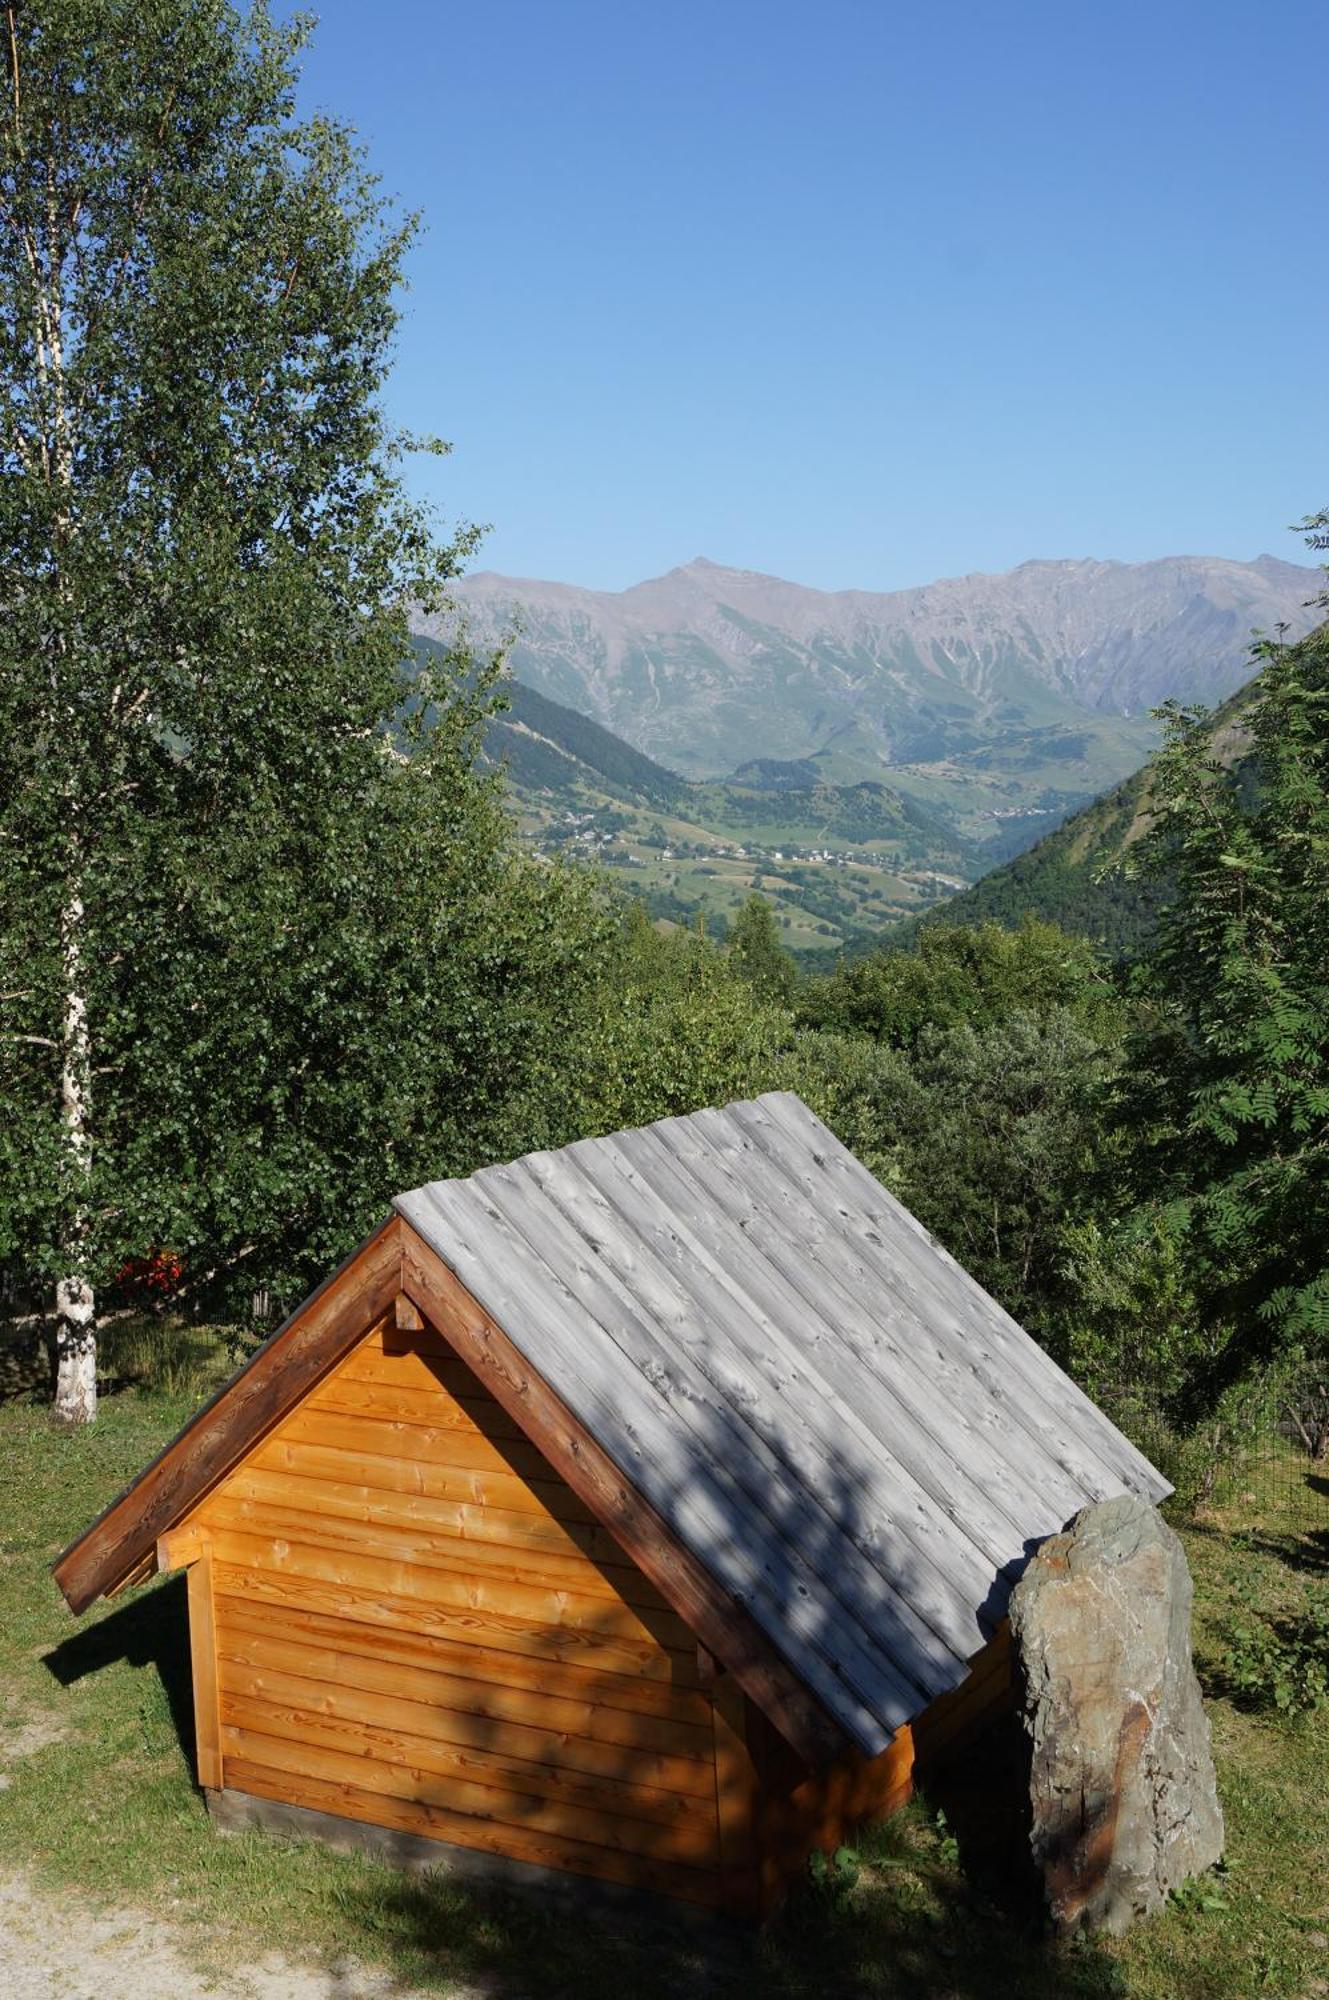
[1133,548,1329,1366]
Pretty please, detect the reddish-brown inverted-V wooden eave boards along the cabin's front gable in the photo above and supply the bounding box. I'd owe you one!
[54,1216,851,1766]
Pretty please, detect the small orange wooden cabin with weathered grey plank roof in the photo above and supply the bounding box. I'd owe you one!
[56,1092,1167,1914]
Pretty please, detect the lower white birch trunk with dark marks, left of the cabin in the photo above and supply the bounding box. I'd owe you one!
[56,892,96,1424]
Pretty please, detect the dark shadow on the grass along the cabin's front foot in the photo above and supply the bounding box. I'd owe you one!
[316,1716,1125,2000]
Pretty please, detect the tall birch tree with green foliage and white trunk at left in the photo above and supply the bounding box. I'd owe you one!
[0,0,498,1420]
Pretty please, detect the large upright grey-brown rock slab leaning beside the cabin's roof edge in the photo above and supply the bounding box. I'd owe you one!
[1011,1494,1223,1932]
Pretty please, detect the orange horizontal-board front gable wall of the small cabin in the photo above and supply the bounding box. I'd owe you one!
[176,1310,723,1904]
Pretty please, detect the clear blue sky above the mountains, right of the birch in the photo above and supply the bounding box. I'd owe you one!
[294,0,1329,588]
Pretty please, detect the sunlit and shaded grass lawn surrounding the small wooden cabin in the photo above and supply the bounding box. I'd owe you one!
[0,1380,1329,2000]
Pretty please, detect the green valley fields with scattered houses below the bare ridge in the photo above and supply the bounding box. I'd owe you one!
[414,638,1157,954]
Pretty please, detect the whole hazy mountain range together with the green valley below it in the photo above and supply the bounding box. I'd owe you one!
[412,556,1323,950]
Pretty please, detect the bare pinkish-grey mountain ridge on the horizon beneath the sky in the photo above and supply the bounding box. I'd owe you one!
[424,556,1319,798]
